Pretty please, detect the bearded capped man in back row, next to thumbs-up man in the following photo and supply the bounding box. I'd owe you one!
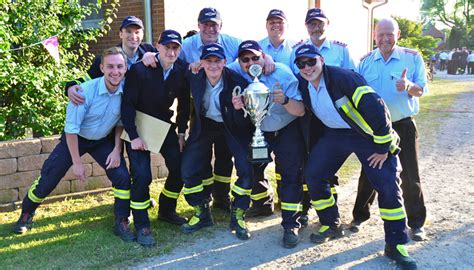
[290,8,355,74]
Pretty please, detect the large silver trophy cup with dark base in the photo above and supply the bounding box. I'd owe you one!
[233,65,272,163]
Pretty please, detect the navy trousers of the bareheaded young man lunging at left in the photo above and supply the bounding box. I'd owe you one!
[22,133,130,218]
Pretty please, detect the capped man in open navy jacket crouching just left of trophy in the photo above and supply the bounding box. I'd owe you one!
[182,43,254,240]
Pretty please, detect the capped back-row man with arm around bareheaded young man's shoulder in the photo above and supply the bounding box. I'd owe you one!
[66,16,156,105]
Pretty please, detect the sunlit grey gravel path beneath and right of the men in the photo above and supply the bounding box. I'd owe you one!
[134,76,474,269]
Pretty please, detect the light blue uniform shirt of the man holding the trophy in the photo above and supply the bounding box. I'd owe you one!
[229,61,302,132]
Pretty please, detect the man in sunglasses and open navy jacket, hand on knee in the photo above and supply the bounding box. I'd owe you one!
[295,44,416,269]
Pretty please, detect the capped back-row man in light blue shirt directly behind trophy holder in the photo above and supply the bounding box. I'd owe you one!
[258,9,296,67]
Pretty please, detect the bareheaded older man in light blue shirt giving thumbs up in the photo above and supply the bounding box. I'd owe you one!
[351,18,428,241]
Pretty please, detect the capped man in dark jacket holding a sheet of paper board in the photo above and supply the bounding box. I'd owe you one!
[122,30,190,246]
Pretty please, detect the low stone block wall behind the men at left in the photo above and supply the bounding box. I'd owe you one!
[0,136,168,210]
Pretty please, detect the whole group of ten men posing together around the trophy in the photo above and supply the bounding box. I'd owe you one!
[14,8,427,269]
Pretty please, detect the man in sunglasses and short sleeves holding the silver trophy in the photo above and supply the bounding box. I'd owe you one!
[229,40,304,248]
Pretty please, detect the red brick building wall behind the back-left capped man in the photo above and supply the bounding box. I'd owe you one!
[89,0,165,55]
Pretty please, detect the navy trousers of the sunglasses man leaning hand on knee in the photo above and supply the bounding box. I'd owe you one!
[305,128,408,245]
